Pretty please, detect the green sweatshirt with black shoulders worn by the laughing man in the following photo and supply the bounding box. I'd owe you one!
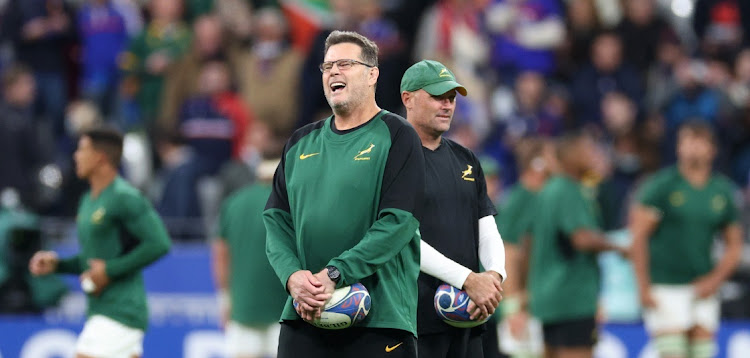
[263,111,425,335]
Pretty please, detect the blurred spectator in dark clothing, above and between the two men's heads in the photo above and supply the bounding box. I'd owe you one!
[355,0,409,112]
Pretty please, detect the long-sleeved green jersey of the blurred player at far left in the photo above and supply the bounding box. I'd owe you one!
[57,177,170,330]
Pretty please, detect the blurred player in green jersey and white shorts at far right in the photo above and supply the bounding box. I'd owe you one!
[630,122,742,358]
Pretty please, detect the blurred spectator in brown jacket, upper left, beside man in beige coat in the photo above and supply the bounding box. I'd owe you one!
[158,15,235,130]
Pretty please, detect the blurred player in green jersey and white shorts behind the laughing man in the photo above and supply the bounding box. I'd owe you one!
[211,123,287,358]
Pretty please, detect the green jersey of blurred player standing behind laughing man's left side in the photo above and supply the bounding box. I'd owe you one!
[219,183,287,327]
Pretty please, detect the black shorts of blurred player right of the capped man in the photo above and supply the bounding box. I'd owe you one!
[542,317,598,348]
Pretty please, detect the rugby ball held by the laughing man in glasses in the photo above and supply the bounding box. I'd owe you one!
[294,283,371,329]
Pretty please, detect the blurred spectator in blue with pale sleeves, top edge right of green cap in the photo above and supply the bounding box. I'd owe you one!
[486,0,565,81]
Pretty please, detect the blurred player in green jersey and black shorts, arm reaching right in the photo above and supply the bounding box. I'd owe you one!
[528,133,626,358]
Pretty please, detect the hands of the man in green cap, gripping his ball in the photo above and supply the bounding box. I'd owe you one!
[463,271,503,320]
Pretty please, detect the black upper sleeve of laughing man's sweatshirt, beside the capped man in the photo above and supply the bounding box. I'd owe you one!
[378,115,425,222]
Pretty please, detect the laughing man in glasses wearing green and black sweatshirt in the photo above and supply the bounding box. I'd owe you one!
[263,31,425,358]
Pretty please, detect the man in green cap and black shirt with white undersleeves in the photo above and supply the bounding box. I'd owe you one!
[401,61,506,358]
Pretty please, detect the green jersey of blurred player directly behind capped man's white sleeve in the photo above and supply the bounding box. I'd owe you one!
[495,183,537,245]
